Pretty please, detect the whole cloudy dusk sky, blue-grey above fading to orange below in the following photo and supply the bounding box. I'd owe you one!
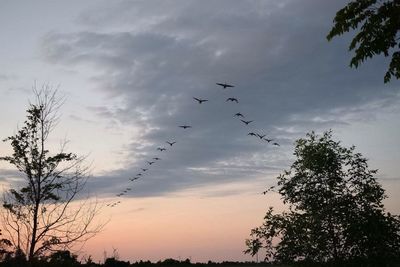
[0,0,400,261]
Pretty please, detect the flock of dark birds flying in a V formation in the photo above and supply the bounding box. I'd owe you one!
[106,83,280,208]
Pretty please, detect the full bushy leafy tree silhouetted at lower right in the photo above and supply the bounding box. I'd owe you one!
[245,132,400,266]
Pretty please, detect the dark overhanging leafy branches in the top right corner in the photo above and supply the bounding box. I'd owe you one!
[327,0,400,83]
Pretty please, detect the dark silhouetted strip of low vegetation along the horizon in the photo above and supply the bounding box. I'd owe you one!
[0,251,400,267]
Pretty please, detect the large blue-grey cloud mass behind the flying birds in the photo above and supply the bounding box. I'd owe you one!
[32,0,399,197]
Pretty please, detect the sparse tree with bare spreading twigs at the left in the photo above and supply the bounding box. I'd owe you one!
[0,85,103,262]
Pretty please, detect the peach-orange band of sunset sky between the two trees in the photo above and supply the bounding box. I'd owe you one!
[81,182,282,262]
